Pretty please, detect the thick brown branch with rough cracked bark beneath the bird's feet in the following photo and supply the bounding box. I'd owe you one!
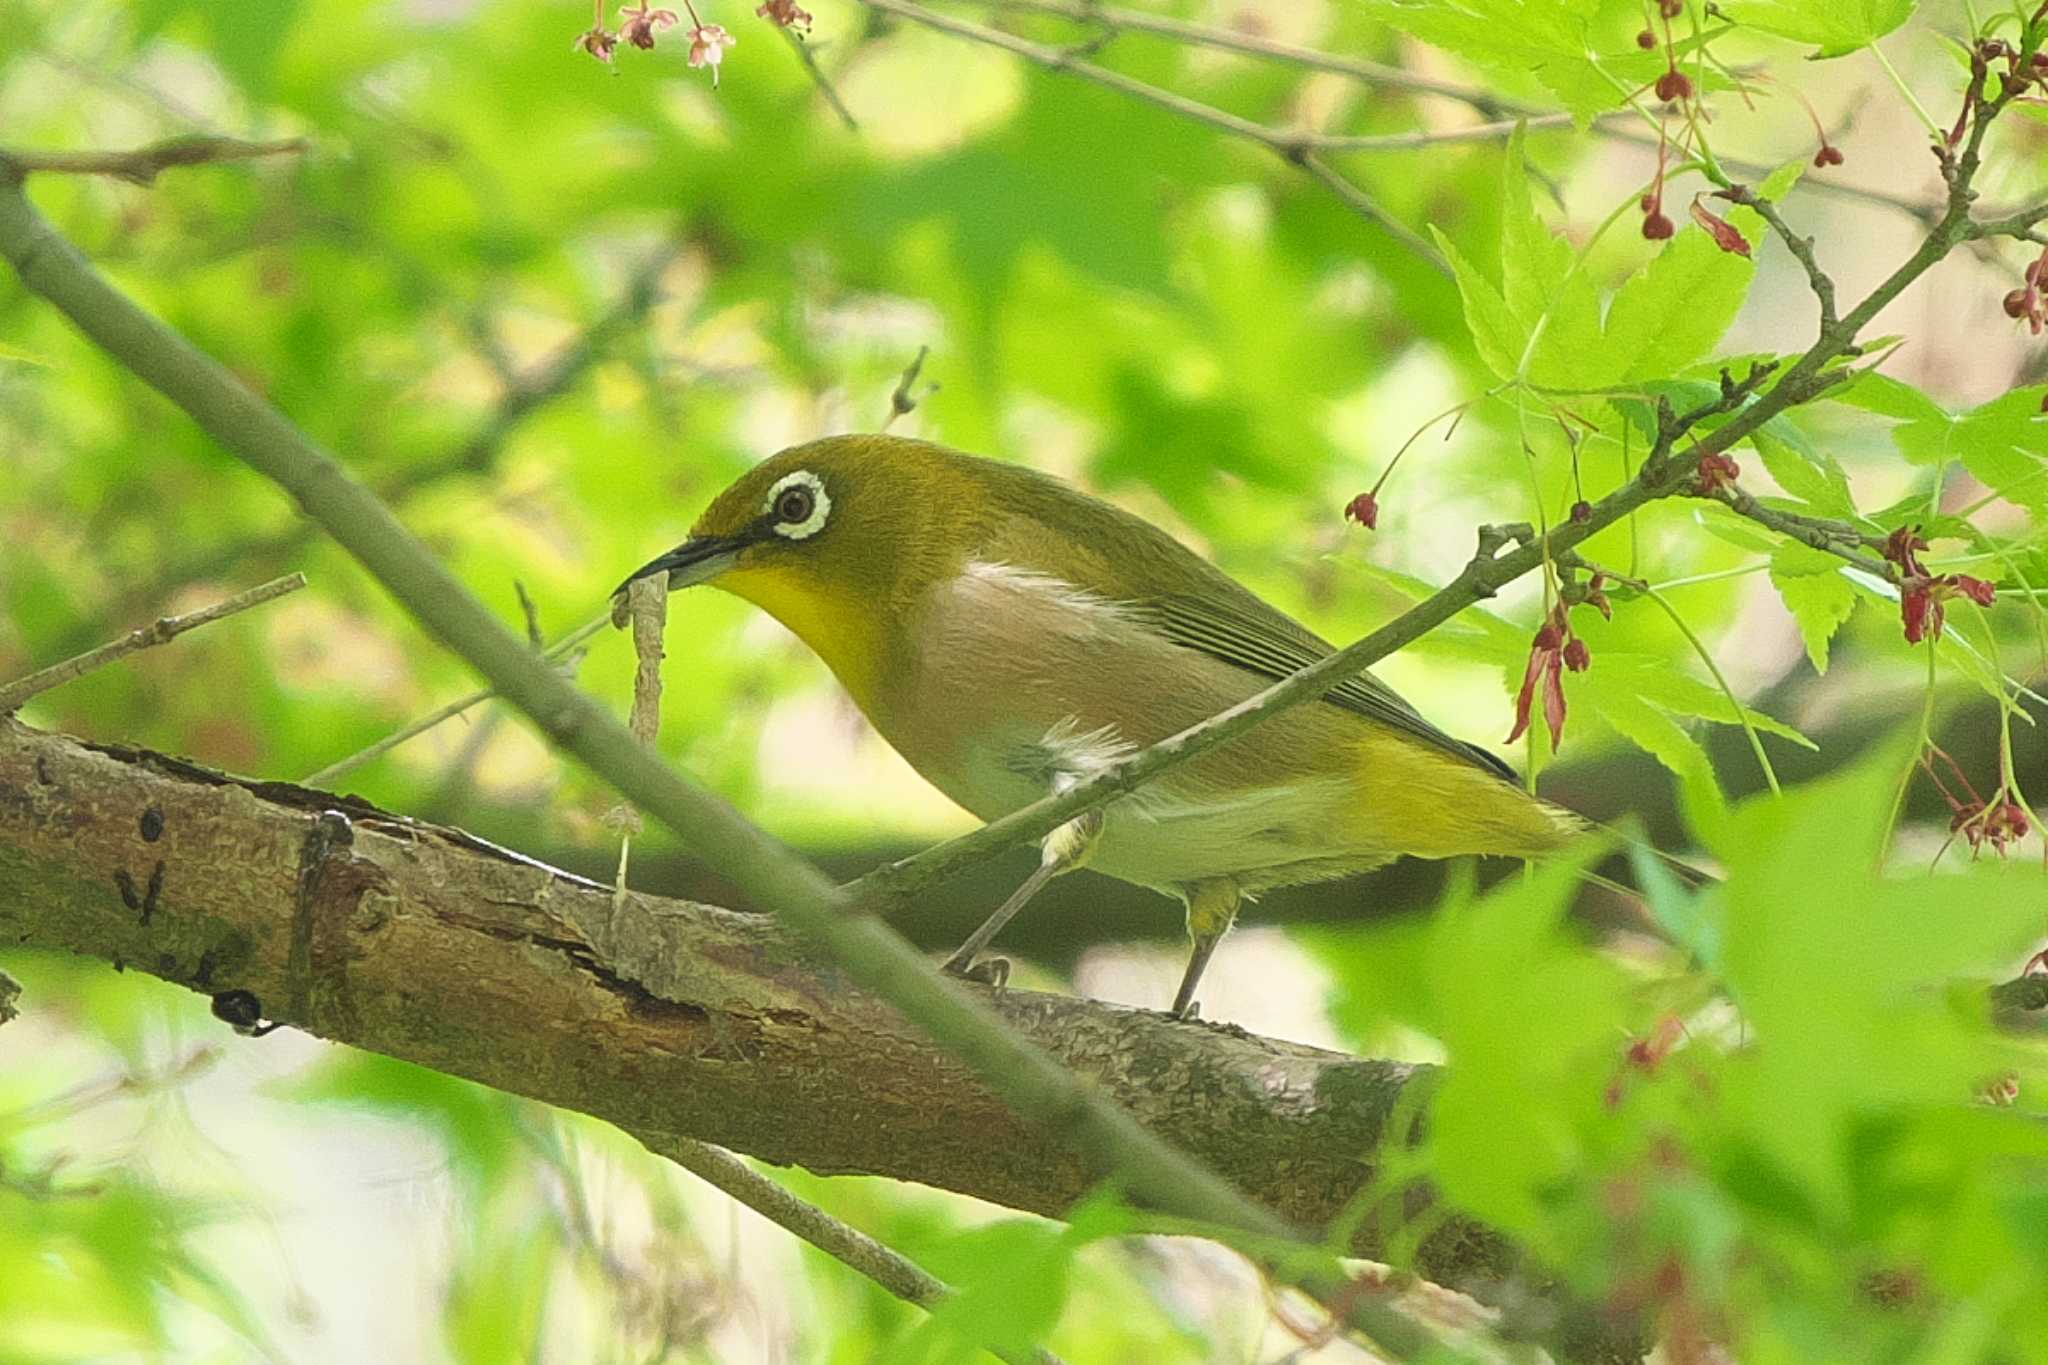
[0,720,1516,1291]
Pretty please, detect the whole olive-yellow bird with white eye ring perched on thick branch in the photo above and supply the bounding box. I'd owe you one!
[627,436,1579,1017]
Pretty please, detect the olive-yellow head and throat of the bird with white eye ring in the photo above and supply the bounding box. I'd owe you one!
[621,436,987,704]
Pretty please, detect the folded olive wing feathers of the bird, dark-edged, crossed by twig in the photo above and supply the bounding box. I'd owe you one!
[1128,596,1516,782]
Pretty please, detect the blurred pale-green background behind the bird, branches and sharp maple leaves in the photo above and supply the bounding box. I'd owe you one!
[0,0,2048,1361]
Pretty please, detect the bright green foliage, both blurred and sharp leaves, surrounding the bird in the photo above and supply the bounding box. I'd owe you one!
[0,0,2048,1363]
